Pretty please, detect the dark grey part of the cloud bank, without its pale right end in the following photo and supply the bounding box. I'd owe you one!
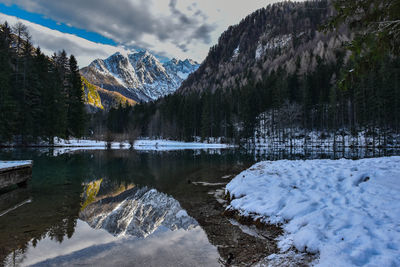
[0,0,215,56]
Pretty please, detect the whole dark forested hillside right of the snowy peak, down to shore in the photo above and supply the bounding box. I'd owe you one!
[122,0,400,147]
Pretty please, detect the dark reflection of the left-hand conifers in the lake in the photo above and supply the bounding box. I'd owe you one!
[0,156,84,265]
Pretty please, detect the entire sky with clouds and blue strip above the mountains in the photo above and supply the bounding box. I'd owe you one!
[0,0,276,67]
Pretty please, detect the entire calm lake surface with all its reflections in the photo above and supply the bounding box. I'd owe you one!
[0,150,399,266]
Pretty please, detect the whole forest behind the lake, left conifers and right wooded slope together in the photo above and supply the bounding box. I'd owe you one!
[0,0,400,149]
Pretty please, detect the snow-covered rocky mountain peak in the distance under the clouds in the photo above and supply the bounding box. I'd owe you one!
[81,51,199,102]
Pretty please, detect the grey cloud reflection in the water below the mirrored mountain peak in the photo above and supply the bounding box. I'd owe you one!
[30,227,219,266]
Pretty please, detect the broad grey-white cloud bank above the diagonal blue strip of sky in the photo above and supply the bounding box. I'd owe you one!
[0,0,276,61]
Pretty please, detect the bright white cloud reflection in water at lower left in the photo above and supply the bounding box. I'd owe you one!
[5,220,116,266]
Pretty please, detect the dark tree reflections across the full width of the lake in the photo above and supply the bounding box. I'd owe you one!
[0,150,398,265]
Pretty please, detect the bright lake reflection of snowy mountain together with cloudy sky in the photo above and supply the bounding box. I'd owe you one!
[4,184,219,266]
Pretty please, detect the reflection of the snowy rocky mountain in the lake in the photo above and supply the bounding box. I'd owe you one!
[79,187,198,238]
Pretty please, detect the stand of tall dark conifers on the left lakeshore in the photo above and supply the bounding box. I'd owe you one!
[0,23,86,144]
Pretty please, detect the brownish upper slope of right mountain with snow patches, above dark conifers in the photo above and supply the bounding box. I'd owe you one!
[179,1,352,93]
